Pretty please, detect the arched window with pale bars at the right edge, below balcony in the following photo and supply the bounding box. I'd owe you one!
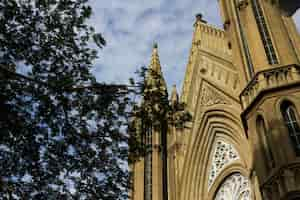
[281,101,300,156]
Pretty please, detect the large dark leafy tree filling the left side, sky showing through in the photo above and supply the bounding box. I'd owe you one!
[0,0,130,200]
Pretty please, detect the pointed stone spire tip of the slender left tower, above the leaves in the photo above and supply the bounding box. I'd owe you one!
[146,43,167,90]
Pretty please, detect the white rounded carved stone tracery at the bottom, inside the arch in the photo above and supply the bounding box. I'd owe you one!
[214,173,251,200]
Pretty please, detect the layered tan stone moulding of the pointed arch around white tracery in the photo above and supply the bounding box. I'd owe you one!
[180,105,253,199]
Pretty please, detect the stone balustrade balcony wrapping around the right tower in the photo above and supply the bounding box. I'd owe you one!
[240,64,300,110]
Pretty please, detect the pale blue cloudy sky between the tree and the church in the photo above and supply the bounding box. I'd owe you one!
[90,0,300,91]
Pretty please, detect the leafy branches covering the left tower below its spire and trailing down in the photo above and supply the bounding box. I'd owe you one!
[129,67,192,162]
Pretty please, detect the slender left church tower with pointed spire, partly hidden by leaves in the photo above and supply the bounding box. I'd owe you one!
[131,44,167,200]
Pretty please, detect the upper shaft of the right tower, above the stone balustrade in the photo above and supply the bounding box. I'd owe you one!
[219,0,300,86]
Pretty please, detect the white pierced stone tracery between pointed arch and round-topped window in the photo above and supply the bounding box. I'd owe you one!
[208,140,240,188]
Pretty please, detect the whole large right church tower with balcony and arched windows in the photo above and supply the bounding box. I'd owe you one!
[220,0,300,199]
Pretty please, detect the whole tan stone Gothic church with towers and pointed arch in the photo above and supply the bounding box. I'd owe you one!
[130,0,300,200]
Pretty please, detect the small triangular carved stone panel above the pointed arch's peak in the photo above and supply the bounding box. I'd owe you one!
[200,86,228,106]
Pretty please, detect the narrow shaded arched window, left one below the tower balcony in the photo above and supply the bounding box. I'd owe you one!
[256,115,275,168]
